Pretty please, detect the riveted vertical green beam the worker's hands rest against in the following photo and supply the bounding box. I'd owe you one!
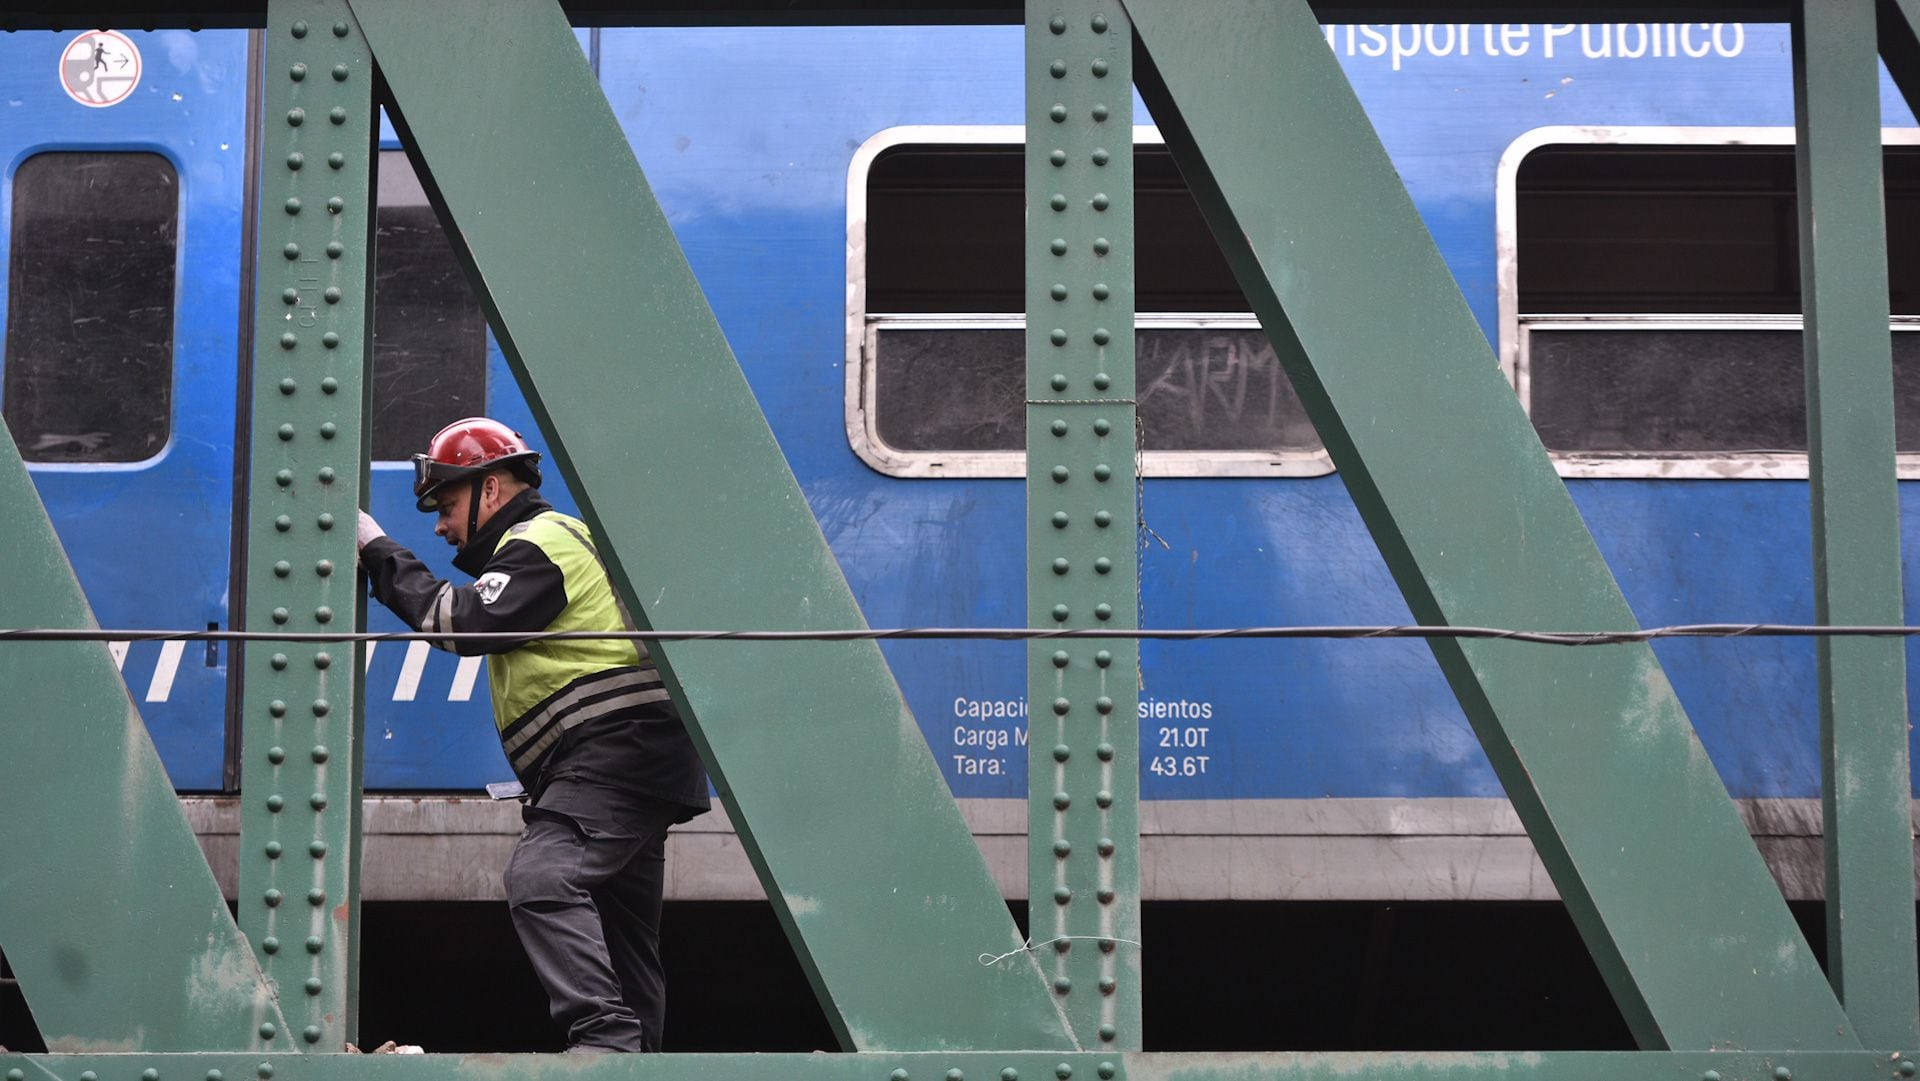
[238,0,374,1050]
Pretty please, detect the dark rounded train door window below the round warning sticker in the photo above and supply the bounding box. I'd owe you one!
[0,152,180,463]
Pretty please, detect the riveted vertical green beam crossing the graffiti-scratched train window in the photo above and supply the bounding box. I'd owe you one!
[1027,0,1140,1048]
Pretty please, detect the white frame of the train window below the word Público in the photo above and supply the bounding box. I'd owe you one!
[1494,127,1920,480]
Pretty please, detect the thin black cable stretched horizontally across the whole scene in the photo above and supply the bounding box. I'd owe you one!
[0,624,1920,645]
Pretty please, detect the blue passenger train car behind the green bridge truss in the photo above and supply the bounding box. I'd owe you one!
[0,23,1920,887]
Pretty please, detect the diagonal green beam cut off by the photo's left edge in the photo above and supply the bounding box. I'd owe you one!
[0,436,280,1050]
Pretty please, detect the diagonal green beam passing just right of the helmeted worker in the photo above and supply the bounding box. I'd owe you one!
[341,0,1069,1050]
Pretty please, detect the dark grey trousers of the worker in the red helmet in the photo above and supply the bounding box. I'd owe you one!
[505,785,676,1052]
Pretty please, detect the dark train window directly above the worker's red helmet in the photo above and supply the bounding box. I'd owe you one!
[371,150,486,459]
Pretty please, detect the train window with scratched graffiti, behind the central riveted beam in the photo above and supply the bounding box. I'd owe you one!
[847,129,1331,476]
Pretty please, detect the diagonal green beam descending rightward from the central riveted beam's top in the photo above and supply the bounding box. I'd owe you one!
[1127,0,1859,1048]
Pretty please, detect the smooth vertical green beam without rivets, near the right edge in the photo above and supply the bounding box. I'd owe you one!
[1793,0,1920,1046]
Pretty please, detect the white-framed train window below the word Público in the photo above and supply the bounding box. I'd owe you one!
[1501,129,1920,476]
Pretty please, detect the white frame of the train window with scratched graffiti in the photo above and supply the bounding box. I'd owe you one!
[845,125,1332,476]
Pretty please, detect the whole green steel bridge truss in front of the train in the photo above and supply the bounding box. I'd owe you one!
[0,0,1920,1081]
